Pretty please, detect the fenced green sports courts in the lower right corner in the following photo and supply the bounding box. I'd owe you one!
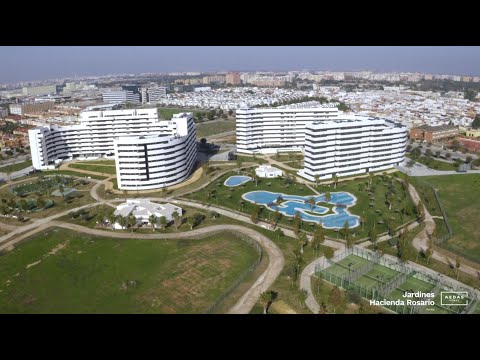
[315,247,477,314]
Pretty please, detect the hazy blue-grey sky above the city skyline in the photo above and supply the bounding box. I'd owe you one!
[0,46,480,83]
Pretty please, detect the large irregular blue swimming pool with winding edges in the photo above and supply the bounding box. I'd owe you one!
[242,190,360,229]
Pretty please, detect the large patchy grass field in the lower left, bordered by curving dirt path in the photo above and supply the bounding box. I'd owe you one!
[0,228,258,313]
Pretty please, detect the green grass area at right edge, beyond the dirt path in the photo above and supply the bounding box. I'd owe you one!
[412,174,480,262]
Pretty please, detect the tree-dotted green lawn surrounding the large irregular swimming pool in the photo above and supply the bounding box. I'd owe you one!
[186,171,414,239]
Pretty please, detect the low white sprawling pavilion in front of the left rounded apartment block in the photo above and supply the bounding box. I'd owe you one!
[113,199,183,229]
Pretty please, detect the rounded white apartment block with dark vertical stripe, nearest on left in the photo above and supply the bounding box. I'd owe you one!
[113,113,197,190]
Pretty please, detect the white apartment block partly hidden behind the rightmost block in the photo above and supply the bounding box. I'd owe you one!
[236,107,341,154]
